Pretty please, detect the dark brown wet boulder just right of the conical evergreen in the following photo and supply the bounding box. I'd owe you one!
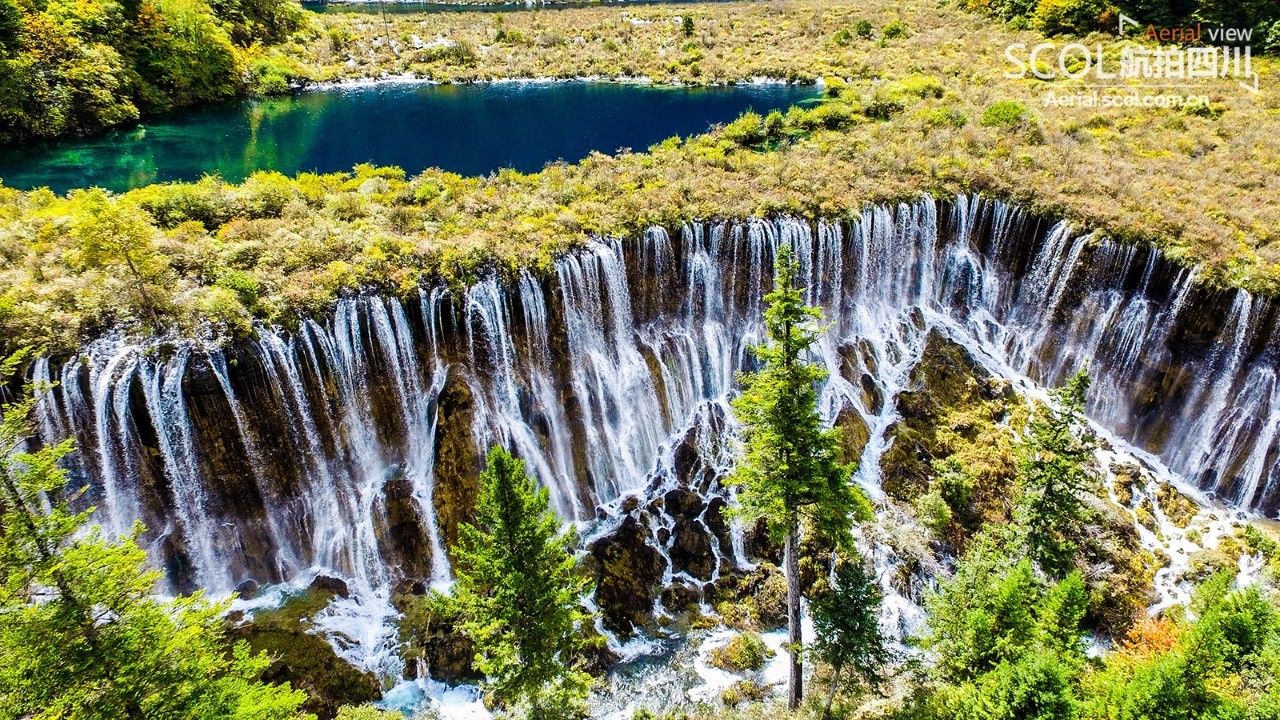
[589,515,666,637]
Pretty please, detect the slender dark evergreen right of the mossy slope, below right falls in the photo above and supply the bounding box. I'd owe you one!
[1015,369,1101,578]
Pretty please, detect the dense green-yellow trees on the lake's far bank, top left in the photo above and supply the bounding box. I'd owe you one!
[0,0,303,143]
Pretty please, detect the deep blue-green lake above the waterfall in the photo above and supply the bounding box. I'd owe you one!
[0,82,817,192]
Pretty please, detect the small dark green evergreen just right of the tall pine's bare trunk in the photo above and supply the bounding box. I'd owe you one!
[809,559,890,719]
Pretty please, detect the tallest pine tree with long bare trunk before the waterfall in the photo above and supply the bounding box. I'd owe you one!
[730,245,870,708]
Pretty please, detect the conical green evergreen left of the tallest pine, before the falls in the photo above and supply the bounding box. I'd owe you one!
[454,447,590,720]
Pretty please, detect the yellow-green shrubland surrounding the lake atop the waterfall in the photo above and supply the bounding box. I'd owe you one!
[0,0,1280,351]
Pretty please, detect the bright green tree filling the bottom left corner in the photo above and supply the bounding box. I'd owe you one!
[0,355,305,720]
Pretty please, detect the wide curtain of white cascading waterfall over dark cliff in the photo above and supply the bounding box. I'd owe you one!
[33,197,1280,676]
